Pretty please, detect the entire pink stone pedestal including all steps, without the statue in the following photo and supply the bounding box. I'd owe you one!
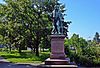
[41,35,78,68]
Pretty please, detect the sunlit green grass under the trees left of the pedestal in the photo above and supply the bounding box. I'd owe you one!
[0,51,50,64]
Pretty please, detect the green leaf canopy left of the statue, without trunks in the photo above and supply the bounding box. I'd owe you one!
[0,0,50,53]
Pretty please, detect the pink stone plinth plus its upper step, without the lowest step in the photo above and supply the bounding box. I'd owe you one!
[45,35,70,65]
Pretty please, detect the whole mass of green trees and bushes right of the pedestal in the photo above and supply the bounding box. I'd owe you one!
[65,34,100,66]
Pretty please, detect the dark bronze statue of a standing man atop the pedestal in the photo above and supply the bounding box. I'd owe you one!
[52,4,63,34]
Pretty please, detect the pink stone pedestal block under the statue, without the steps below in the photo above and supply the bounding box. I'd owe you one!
[50,35,65,59]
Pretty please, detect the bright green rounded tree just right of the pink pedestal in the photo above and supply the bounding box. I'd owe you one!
[65,34,88,54]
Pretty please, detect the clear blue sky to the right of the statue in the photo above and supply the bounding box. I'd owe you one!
[0,0,100,40]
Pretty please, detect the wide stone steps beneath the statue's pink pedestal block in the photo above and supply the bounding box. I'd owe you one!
[41,58,78,68]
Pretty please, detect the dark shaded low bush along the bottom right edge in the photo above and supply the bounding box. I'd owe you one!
[69,52,100,67]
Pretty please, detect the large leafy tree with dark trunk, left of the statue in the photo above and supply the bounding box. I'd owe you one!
[0,0,67,56]
